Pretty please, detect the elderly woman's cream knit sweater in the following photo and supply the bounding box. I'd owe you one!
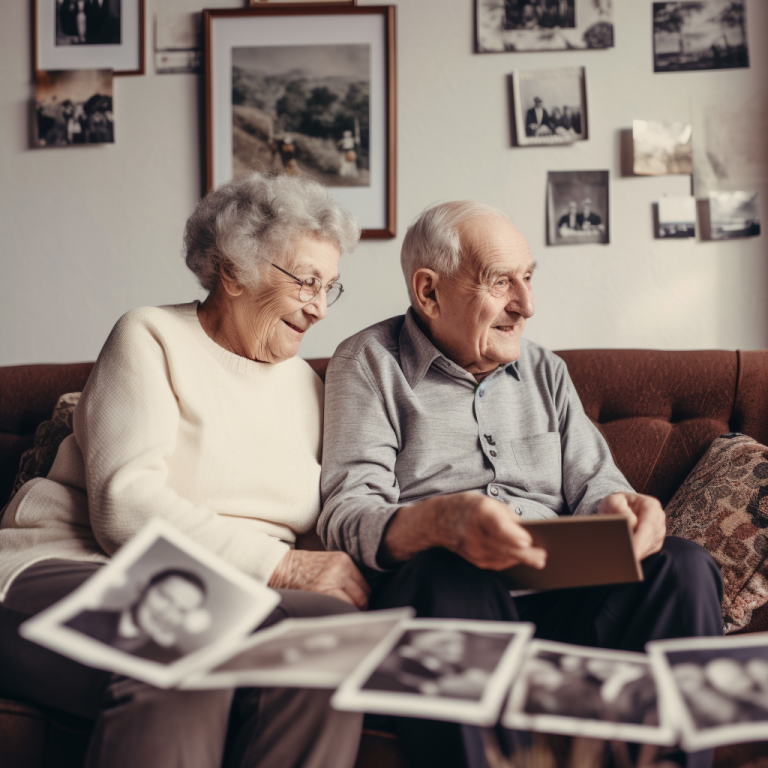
[0,302,323,600]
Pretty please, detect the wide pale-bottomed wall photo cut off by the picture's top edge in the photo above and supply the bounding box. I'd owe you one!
[475,0,613,53]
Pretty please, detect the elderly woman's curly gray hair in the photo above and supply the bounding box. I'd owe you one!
[183,172,360,292]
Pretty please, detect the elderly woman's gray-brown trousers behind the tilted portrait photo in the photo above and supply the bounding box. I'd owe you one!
[0,560,362,768]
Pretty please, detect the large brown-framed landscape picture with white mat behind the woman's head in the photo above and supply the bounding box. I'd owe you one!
[203,3,395,238]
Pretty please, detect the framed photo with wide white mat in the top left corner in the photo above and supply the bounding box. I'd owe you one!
[34,0,145,75]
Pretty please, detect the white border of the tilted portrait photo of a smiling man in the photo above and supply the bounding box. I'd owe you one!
[19,518,280,688]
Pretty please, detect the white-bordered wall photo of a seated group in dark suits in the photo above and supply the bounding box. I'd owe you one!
[512,67,588,146]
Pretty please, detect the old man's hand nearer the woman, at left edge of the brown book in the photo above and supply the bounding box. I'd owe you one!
[433,492,547,571]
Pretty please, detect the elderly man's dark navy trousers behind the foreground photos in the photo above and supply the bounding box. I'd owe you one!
[370,536,723,768]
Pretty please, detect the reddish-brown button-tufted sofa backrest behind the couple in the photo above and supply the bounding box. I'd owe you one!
[0,349,768,507]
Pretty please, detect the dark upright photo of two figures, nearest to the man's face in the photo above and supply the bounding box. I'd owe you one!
[547,171,610,245]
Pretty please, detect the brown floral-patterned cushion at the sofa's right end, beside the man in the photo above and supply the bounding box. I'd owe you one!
[666,433,768,633]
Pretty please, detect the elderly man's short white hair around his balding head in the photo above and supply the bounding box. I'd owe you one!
[400,200,510,306]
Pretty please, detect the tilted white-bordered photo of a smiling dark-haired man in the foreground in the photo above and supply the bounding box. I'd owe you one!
[19,518,280,688]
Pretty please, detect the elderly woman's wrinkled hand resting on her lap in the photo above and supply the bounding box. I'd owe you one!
[268,549,371,610]
